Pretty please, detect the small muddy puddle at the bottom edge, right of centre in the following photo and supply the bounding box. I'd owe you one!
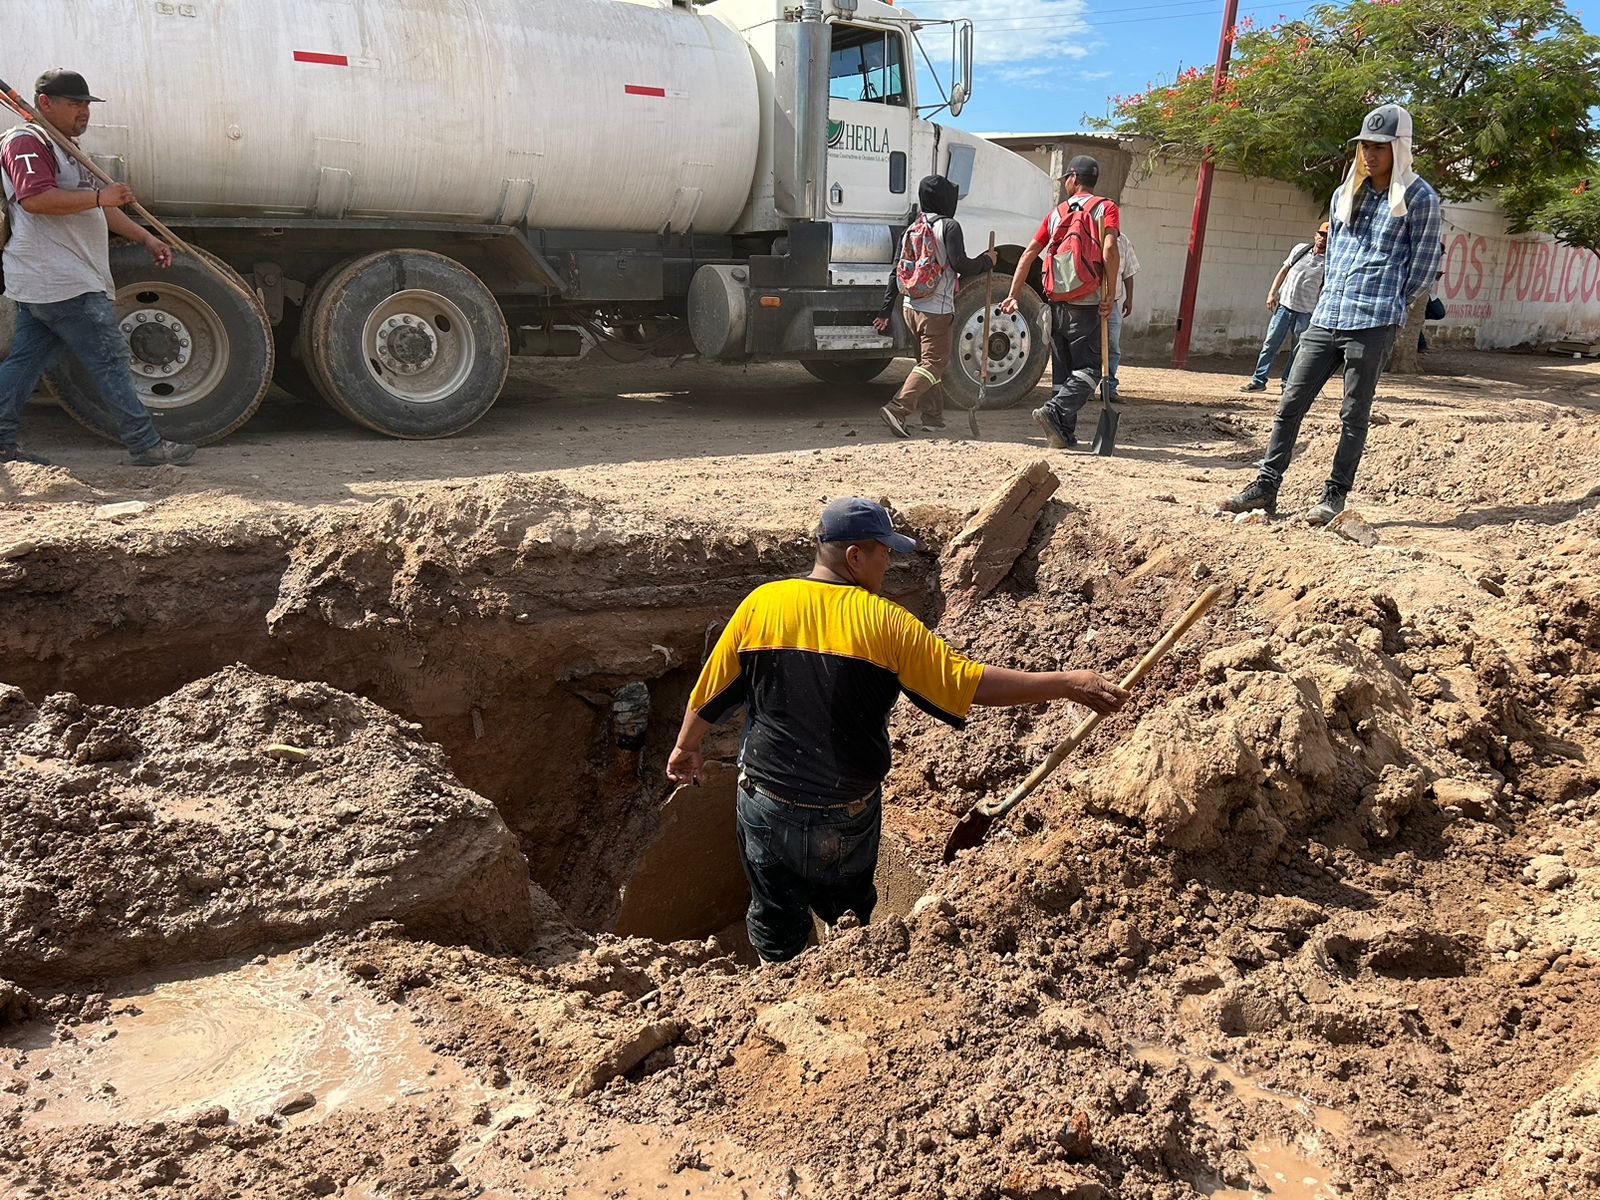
[1138,1046,1352,1200]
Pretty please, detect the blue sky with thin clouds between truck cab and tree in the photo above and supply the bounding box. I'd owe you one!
[921,0,1600,133]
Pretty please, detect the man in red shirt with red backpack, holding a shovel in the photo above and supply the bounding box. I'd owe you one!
[1000,154,1122,450]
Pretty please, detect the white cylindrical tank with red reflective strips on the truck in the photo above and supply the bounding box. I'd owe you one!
[12,0,760,232]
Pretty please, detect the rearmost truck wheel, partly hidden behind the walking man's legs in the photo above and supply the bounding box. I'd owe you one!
[45,245,274,445]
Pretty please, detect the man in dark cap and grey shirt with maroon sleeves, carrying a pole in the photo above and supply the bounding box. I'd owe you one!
[0,67,195,467]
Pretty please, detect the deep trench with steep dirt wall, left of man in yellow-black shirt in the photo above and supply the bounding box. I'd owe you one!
[0,483,939,941]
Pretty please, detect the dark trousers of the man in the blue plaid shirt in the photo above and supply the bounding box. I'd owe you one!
[1261,325,1400,494]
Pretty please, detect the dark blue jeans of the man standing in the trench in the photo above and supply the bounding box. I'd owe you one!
[738,779,883,963]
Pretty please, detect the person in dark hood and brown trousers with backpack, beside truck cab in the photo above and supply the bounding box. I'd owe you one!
[872,174,997,437]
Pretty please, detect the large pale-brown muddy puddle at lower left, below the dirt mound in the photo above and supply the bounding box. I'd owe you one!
[0,955,488,1125]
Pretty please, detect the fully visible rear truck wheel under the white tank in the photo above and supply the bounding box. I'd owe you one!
[301,250,510,438]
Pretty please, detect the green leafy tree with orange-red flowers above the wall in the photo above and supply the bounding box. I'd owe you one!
[1101,0,1600,203]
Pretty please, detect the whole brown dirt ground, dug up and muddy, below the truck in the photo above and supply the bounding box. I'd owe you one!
[0,354,1600,1200]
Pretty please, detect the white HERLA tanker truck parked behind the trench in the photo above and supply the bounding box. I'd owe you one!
[9,0,1051,442]
